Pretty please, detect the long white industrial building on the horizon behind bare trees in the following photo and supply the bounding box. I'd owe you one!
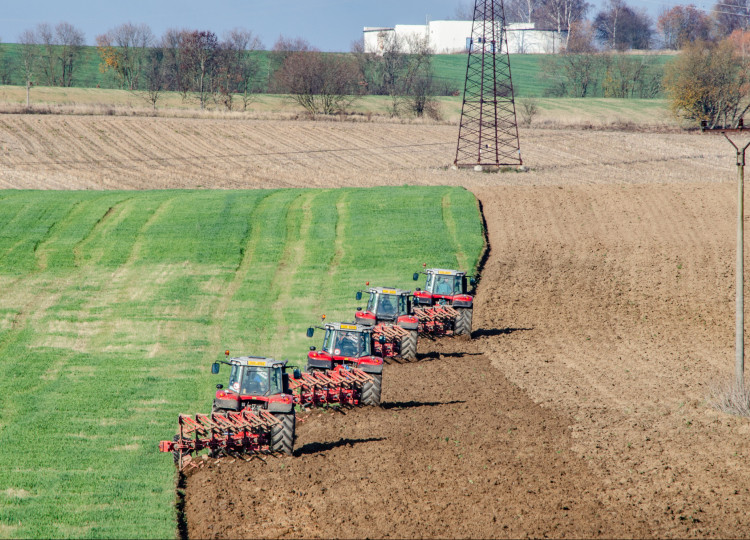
[364,21,565,54]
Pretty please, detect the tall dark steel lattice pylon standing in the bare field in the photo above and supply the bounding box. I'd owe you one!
[453,0,523,167]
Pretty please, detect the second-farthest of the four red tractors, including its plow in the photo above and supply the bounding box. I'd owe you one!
[355,287,419,360]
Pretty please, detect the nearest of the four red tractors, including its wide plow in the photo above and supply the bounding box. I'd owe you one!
[159,351,300,468]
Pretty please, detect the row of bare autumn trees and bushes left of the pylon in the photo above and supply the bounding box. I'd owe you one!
[0,22,446,117]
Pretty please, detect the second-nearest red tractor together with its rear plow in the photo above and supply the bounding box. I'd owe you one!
[306,317,383,407]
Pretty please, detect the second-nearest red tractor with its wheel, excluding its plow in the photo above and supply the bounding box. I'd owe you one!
[305,317,383,406]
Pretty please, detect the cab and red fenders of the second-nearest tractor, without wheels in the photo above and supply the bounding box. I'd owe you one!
[307,323,383,373]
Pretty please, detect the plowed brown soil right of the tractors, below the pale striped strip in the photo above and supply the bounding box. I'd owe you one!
[186,180,750,538]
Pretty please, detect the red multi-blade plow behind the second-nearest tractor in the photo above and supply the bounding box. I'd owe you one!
[289,366,372,407]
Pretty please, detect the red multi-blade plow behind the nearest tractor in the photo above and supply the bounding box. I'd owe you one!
[159,409,281,469]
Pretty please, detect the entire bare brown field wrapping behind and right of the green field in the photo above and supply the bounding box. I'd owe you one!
[0,116,750,538]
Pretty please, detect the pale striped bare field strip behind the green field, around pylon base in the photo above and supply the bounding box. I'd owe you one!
[0,114,734,189]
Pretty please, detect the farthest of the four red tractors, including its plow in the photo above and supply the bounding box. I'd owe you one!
[414,264,475,336]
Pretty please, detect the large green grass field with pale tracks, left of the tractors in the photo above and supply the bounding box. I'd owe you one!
[0,187,483,538]
